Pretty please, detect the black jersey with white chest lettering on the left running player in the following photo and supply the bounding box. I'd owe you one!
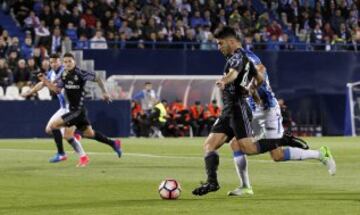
[57,67,96,111]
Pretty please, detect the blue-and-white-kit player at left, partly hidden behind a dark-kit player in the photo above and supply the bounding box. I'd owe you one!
[22,54,89,167]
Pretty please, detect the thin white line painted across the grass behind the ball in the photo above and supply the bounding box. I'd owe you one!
[0,148,318,165]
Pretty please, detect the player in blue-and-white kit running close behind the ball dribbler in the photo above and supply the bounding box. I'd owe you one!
[228,49,336,196]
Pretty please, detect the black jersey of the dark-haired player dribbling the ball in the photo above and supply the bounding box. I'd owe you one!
[222,49,255,115]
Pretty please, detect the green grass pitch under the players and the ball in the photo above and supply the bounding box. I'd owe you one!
[0,137,360,215]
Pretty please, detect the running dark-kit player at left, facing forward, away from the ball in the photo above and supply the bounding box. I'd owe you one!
[39,53,122,157]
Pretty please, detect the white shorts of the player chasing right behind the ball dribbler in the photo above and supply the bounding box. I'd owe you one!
[251,105,284,140]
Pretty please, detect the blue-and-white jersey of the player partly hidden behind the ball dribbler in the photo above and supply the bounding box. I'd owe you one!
[242,49,277,111]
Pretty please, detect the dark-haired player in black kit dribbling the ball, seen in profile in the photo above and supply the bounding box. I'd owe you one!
[192,27,308,196]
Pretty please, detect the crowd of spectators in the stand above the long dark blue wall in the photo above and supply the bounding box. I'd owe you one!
[3,0,360,51]
